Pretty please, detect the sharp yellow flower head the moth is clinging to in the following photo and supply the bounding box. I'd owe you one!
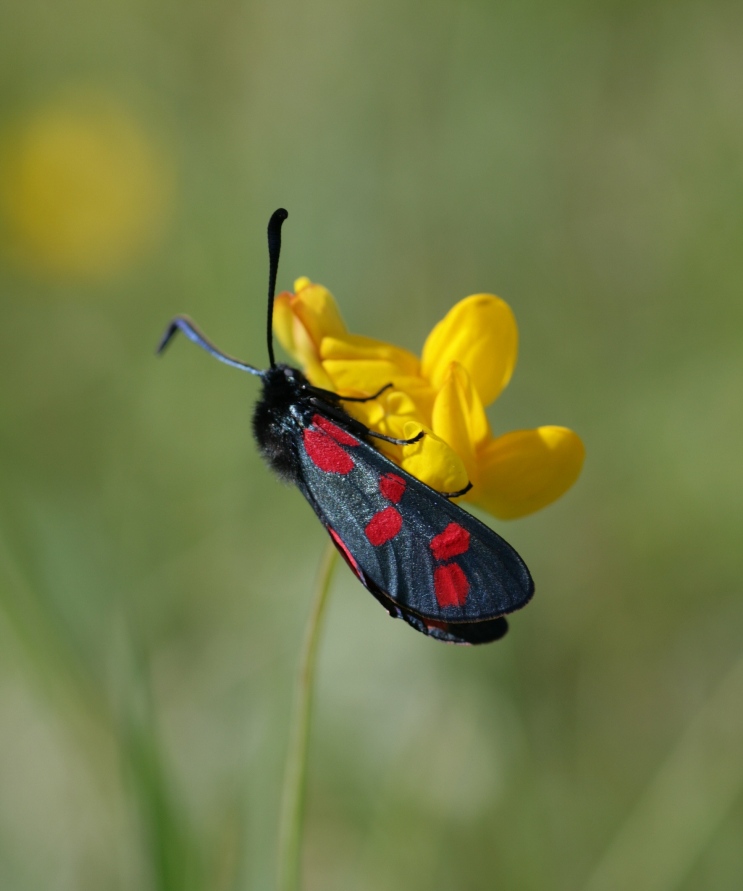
[274,278,584,519]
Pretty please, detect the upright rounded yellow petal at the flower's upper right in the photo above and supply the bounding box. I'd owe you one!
[422,294,518,405]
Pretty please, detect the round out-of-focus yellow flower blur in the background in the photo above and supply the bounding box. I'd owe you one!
[0,96,172,280]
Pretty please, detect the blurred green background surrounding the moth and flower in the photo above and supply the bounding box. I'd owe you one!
[0,0,743,891]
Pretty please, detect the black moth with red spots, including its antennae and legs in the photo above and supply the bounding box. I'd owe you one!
[158,209,534,644]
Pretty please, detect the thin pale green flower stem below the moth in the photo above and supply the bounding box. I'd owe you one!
[277,541,338,891]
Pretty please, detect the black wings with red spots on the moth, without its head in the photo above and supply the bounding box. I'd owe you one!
[299,414,534,643]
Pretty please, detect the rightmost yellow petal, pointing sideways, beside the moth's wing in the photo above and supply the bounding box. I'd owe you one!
[471,427,585,520]
